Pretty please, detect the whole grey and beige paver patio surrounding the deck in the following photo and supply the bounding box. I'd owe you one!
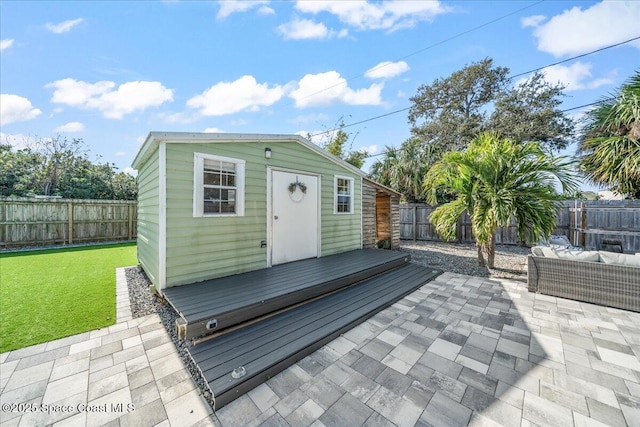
[0,272,640,427]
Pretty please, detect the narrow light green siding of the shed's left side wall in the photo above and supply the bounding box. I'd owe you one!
[137,150,160,284]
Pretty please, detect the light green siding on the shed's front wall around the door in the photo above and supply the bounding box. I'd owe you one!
[166,142,362,286]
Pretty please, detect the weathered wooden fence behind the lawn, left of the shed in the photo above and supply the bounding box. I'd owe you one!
[0,197,138,248]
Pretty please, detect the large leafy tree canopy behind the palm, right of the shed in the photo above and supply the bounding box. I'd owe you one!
[372,58,574,201]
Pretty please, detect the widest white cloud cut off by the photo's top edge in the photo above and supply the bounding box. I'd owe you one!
[296,0,447,30]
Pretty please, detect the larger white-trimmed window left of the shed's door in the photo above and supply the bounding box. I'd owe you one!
[193,153,245,217]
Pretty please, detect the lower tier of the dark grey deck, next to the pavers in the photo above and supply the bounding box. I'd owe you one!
[188,262,440,409]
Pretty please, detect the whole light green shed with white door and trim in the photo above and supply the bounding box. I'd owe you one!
[133,132,365,290]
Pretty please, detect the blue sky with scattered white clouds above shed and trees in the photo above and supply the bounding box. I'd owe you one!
[0,0,640,191]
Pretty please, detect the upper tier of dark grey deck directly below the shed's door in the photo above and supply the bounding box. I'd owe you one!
[163,249,409,339]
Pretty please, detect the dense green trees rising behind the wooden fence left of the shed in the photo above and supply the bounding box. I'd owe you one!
[0,135,138,200]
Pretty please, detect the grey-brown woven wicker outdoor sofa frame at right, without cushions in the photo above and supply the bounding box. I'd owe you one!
[527,255,640,312]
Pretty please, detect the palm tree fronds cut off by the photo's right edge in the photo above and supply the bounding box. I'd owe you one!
[578,72,640,199]
